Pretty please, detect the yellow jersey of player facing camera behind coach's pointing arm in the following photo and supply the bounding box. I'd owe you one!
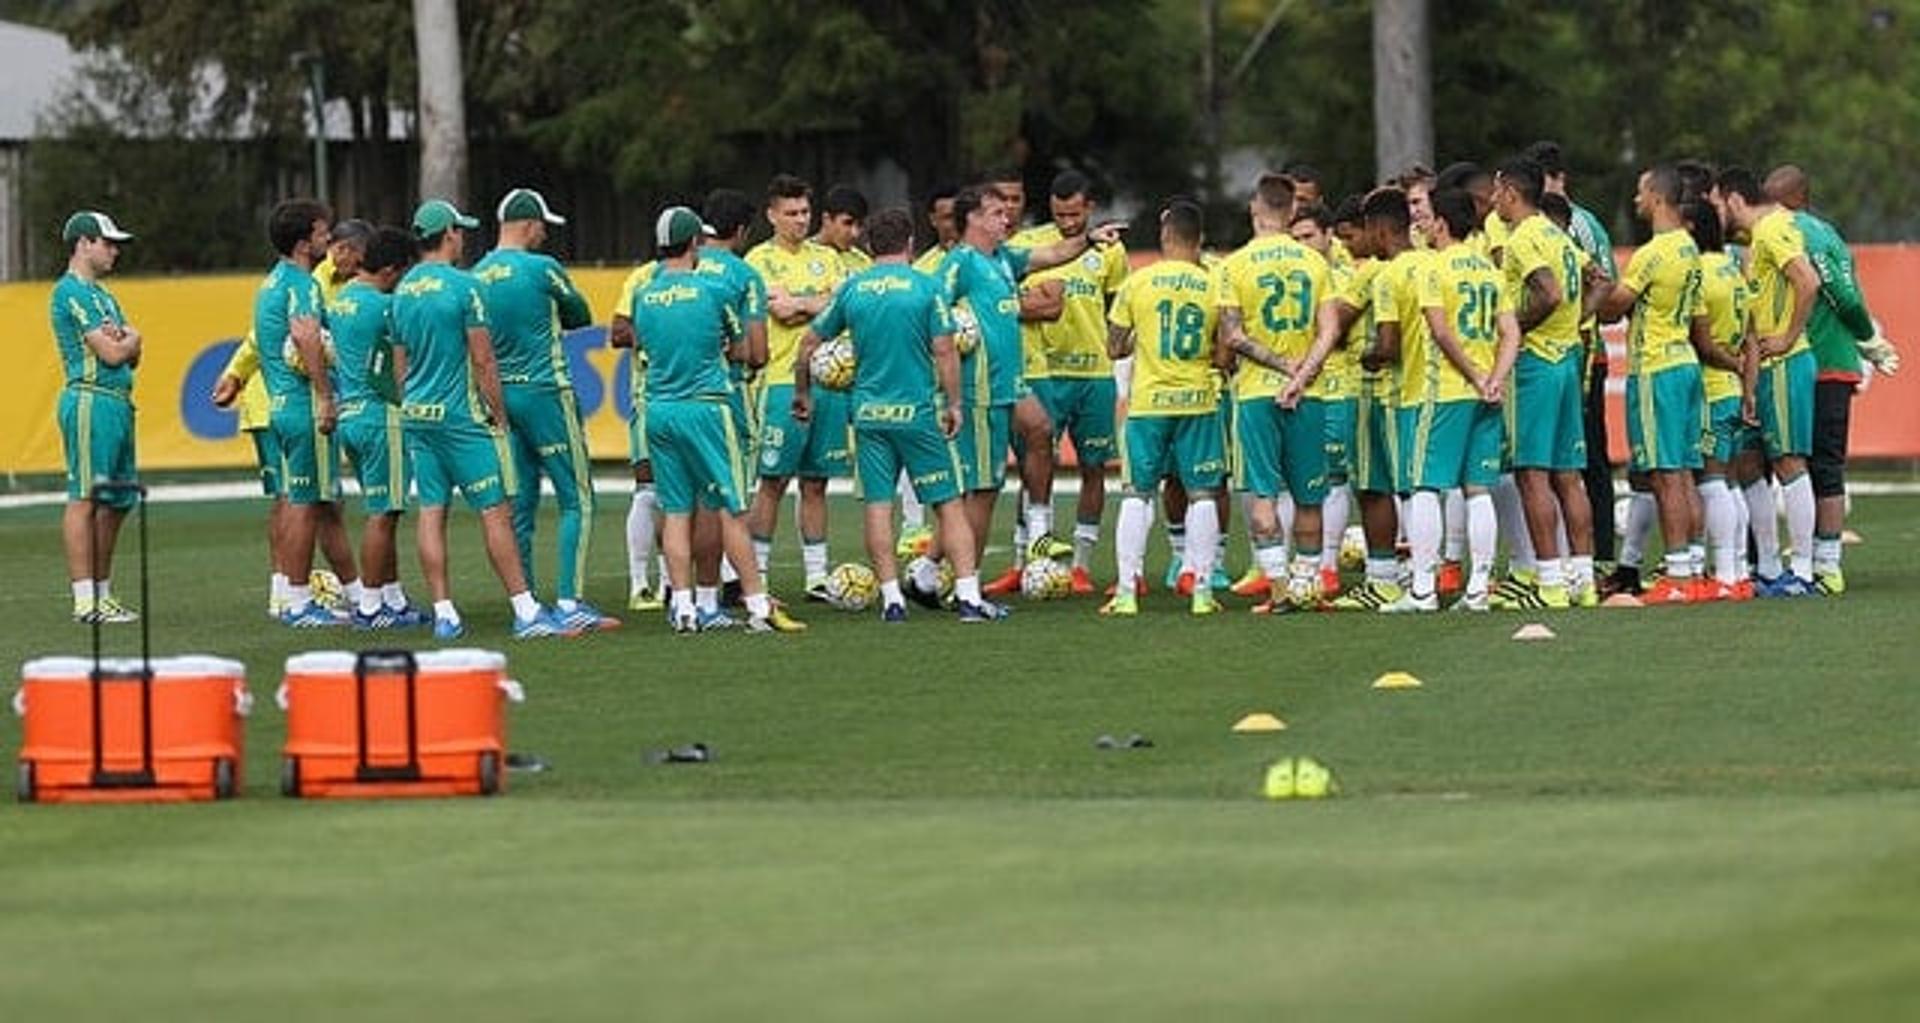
[1008,225,1127,380]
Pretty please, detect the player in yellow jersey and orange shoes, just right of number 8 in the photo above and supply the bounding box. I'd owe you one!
[1599,163,1705,603]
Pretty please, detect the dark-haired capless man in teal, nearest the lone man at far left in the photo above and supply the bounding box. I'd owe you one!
[253,200,361,628]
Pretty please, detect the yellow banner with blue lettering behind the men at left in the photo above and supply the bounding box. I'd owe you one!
[0,269,645,474]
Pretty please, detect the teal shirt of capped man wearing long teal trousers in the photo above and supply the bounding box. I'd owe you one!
[472,250,593,388]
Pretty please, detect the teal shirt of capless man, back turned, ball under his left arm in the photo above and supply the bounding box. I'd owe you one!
[812,263,954,428]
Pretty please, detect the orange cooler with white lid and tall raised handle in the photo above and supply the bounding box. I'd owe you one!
[13,656,252,802]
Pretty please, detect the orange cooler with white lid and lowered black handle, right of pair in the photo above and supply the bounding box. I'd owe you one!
[278,649,522,798]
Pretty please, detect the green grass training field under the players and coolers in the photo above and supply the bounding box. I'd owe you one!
[0,497,1920,1021]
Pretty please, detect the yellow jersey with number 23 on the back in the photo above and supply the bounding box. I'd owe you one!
[1213,234,1332,401]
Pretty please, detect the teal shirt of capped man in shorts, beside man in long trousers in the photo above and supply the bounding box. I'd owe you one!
[392,263,488,422]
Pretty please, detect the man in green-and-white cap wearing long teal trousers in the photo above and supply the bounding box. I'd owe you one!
[472,188,620,631]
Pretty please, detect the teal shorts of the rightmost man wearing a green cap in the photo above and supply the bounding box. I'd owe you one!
[647,401,747,514]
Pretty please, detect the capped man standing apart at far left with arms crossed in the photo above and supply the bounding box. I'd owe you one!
[50,209,142,624]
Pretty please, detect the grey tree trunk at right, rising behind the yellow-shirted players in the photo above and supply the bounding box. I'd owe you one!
[1373,0,1434,180]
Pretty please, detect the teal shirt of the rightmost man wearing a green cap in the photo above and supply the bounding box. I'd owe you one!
[634,265,741,403]
